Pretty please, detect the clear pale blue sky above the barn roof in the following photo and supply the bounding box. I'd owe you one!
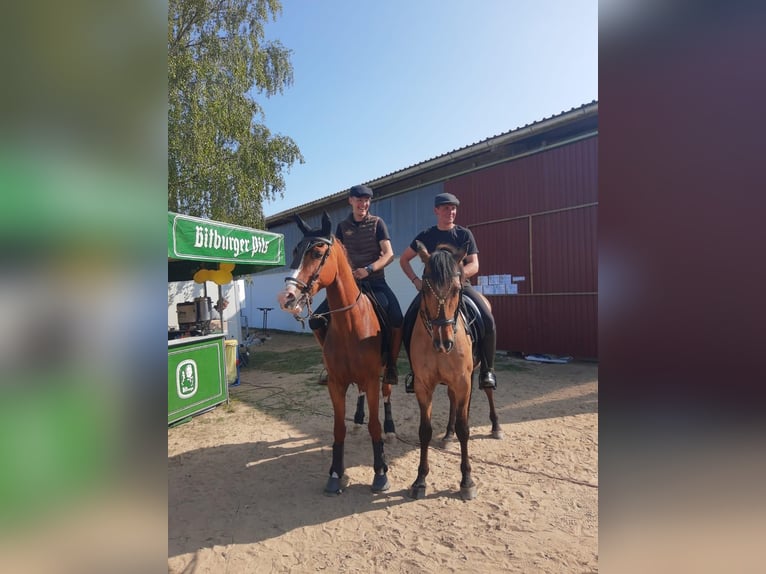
[257,0,598,216]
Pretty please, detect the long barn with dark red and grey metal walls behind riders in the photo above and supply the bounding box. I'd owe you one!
[254,102,598,359]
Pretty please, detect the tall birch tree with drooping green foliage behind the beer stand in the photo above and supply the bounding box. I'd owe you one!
[168,0,303,227]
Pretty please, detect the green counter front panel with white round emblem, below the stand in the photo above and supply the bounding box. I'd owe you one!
[168,334,229,424]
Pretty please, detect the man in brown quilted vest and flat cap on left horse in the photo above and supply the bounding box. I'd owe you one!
[309,185,403,385]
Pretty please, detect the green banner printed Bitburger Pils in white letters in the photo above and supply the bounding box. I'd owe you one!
[168,212,285,266]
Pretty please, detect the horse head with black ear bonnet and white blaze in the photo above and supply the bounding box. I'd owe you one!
[277,211,336,316]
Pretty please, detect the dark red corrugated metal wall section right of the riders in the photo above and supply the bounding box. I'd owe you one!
[444,137,598,358]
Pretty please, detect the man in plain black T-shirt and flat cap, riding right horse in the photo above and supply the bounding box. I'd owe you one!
[399,193,497,393]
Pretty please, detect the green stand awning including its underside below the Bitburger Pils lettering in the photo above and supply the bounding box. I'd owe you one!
[168,211,285,281]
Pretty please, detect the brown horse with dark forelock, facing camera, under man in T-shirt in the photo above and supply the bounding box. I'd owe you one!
[409,242,486,500]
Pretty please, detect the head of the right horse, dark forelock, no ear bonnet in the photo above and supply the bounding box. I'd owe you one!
[416,241,467,353]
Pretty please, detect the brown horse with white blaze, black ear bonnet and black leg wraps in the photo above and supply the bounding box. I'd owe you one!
[277,212,391,494]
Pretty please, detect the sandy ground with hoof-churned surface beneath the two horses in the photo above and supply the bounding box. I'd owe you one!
[168,333,598,573]
